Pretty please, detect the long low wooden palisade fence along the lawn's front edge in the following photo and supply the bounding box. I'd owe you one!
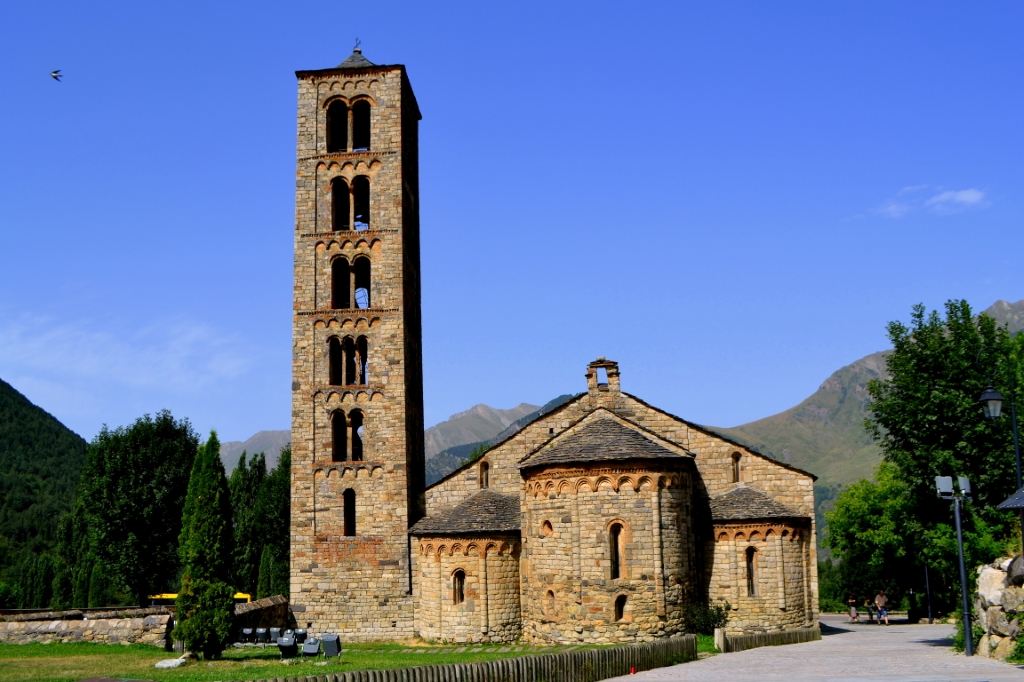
[232,635,697,682]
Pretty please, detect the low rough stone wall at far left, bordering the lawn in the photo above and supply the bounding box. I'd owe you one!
[0,612,174,648]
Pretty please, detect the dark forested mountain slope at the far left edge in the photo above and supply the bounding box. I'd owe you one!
[0,380,86,579]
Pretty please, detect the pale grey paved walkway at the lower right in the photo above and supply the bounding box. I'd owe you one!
[616,615,1024,682]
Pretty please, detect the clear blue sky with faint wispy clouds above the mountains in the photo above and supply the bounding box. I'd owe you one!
[0,2,1024,439]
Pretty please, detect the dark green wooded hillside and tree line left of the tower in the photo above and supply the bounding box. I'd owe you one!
[0,395,291,609]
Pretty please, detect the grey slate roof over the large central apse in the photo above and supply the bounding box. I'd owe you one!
[519,418,687,469]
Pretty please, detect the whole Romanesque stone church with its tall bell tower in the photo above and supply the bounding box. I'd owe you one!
[290,48,818,644]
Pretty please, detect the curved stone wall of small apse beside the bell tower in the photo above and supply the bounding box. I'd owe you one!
[416,537,521,642]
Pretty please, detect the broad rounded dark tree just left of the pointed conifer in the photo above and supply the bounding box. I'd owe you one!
[79,410,199,605]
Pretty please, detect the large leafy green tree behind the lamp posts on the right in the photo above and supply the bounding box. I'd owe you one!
[824,301,1021,610]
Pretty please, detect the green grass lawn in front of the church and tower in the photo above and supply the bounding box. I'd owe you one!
[0,638,598,682]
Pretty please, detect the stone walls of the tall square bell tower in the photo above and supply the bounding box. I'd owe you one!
[291,62,422,640]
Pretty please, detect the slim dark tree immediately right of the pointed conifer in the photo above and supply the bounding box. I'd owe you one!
[227,452,266,594]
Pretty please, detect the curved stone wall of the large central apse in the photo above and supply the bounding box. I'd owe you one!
[522,464,692,643]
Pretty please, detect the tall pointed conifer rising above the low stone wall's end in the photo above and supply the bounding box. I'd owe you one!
[174,432,234,658]
